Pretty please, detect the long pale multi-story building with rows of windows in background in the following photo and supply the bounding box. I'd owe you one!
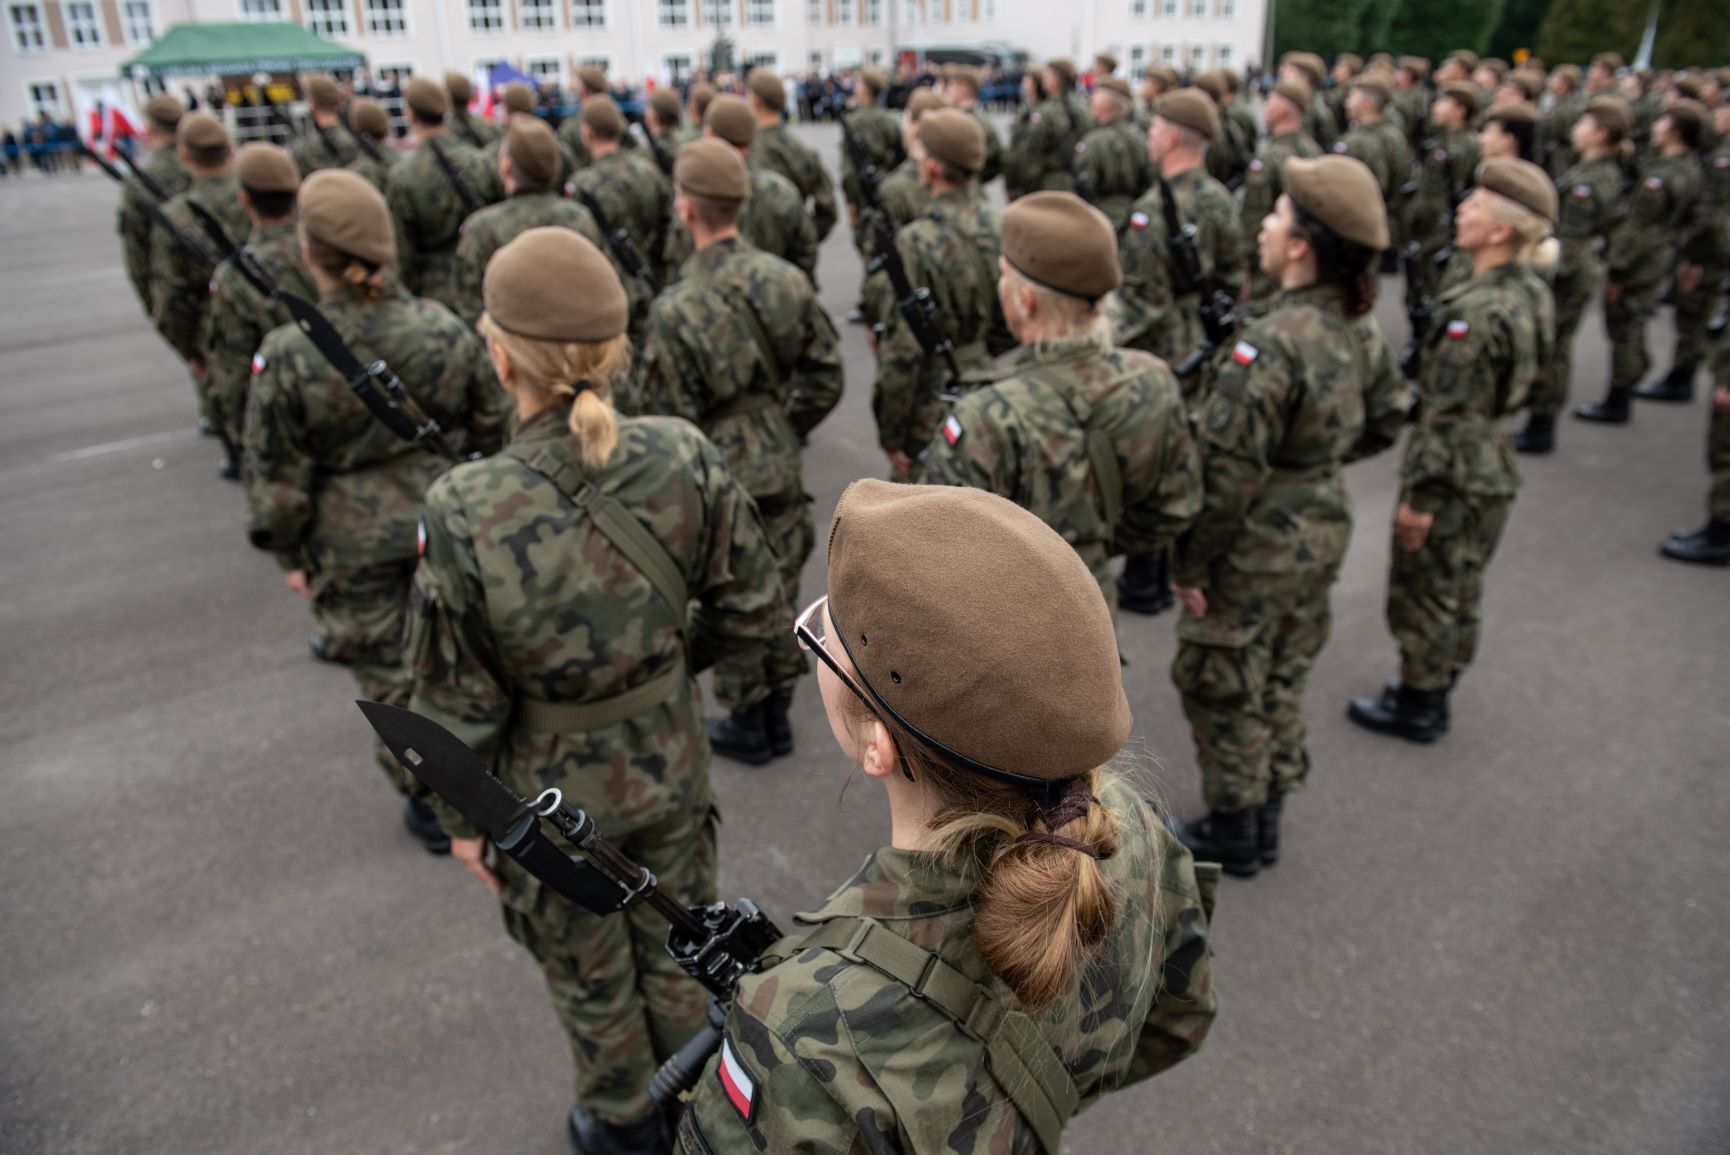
[0,0,1268,136]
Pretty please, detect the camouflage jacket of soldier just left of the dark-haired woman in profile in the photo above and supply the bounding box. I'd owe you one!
[1116,166,1244,361]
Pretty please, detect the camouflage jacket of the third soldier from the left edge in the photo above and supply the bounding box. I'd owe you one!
[204,218,318,444]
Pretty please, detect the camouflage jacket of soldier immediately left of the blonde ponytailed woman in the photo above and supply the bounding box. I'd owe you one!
[246,284,507,572]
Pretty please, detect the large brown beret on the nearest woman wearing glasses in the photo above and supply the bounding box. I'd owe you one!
[829,479,1130,790]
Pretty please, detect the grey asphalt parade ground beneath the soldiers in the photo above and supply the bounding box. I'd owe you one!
[0,128,1730,1155]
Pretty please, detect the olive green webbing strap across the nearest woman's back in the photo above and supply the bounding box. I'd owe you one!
[798,918,1081,1155]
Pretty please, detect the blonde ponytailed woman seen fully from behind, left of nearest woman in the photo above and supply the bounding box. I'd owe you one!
[408,228,791,1153]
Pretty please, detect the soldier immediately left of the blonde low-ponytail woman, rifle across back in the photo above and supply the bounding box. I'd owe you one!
[244,169,505,854]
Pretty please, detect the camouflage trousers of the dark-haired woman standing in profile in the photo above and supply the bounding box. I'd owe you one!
[1171,587,1334,811]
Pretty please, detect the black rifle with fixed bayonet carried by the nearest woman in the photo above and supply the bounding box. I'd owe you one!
[356,702,780,1107]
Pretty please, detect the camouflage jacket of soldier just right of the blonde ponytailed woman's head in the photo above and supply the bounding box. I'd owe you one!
[638,237,841,507]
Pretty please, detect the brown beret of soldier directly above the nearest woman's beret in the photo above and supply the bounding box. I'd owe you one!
[1003,192,1123,303]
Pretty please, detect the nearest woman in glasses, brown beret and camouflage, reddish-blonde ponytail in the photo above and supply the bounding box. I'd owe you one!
[680,481,1216,1155]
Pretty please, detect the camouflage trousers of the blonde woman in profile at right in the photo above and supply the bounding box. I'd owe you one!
[1387,495,1514,690]
